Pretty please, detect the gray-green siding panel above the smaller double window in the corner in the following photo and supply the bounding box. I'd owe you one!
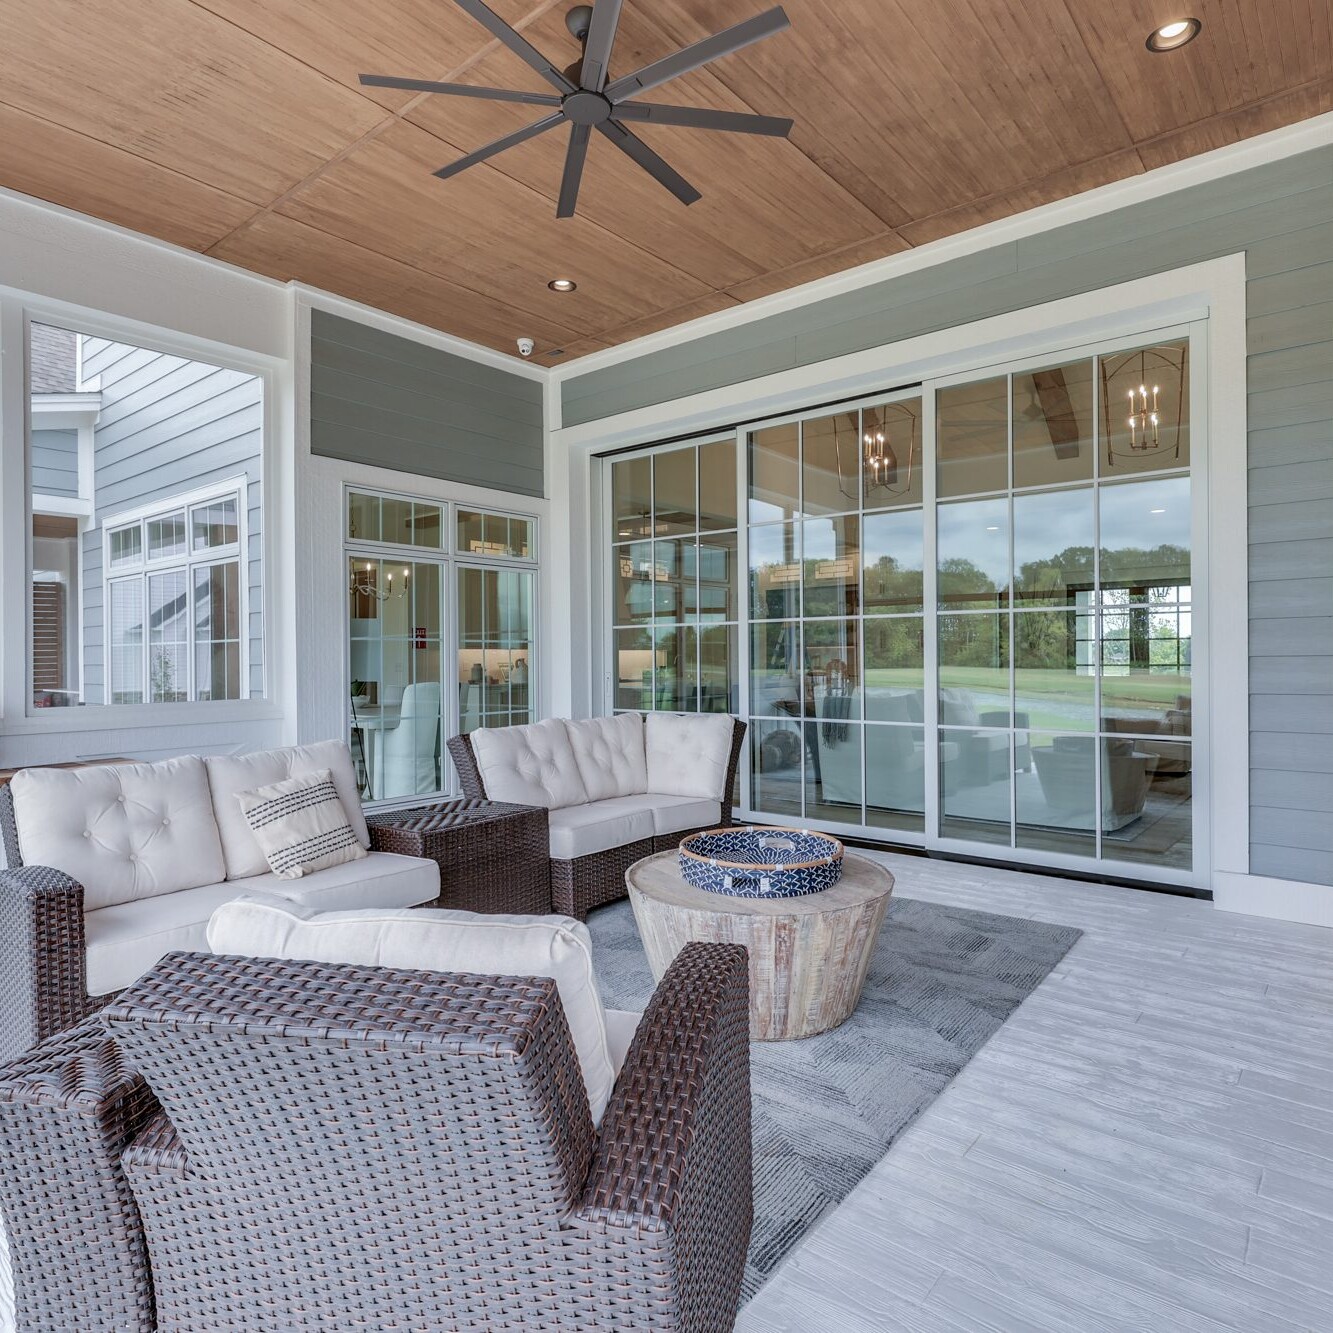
[311,311,544,496]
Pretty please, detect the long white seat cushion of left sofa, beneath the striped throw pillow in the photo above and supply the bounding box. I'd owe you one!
[84,852,440,996]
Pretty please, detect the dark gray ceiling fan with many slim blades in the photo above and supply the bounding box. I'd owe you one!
[361,0,792,217]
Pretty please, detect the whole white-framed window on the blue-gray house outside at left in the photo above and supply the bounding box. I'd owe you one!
[107,481,247,704]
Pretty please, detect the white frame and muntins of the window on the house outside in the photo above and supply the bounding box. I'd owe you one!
[101,475,252,708]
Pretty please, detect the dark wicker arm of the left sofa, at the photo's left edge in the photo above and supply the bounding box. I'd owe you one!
[0,786,111,1060]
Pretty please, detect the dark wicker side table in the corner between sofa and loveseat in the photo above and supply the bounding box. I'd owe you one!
[365,797,551,916]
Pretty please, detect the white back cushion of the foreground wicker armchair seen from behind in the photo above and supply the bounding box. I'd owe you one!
[208,896,617,1120]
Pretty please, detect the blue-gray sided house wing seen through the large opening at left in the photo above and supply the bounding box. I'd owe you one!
[29,324,264,706]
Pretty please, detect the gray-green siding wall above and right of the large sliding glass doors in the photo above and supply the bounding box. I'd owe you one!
[563,148,1333,884]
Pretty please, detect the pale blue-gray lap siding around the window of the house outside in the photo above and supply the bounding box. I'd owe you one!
[83,337,264,702]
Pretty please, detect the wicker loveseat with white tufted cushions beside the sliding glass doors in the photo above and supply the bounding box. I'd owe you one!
[449,713,745,921]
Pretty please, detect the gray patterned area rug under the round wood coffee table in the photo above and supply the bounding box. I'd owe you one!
[588,897,1082,1300]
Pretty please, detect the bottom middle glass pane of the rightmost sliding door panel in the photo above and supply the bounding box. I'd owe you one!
[1014,732,1093,856]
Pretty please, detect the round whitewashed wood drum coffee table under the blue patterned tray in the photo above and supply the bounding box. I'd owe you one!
[625,852,893,1041]
